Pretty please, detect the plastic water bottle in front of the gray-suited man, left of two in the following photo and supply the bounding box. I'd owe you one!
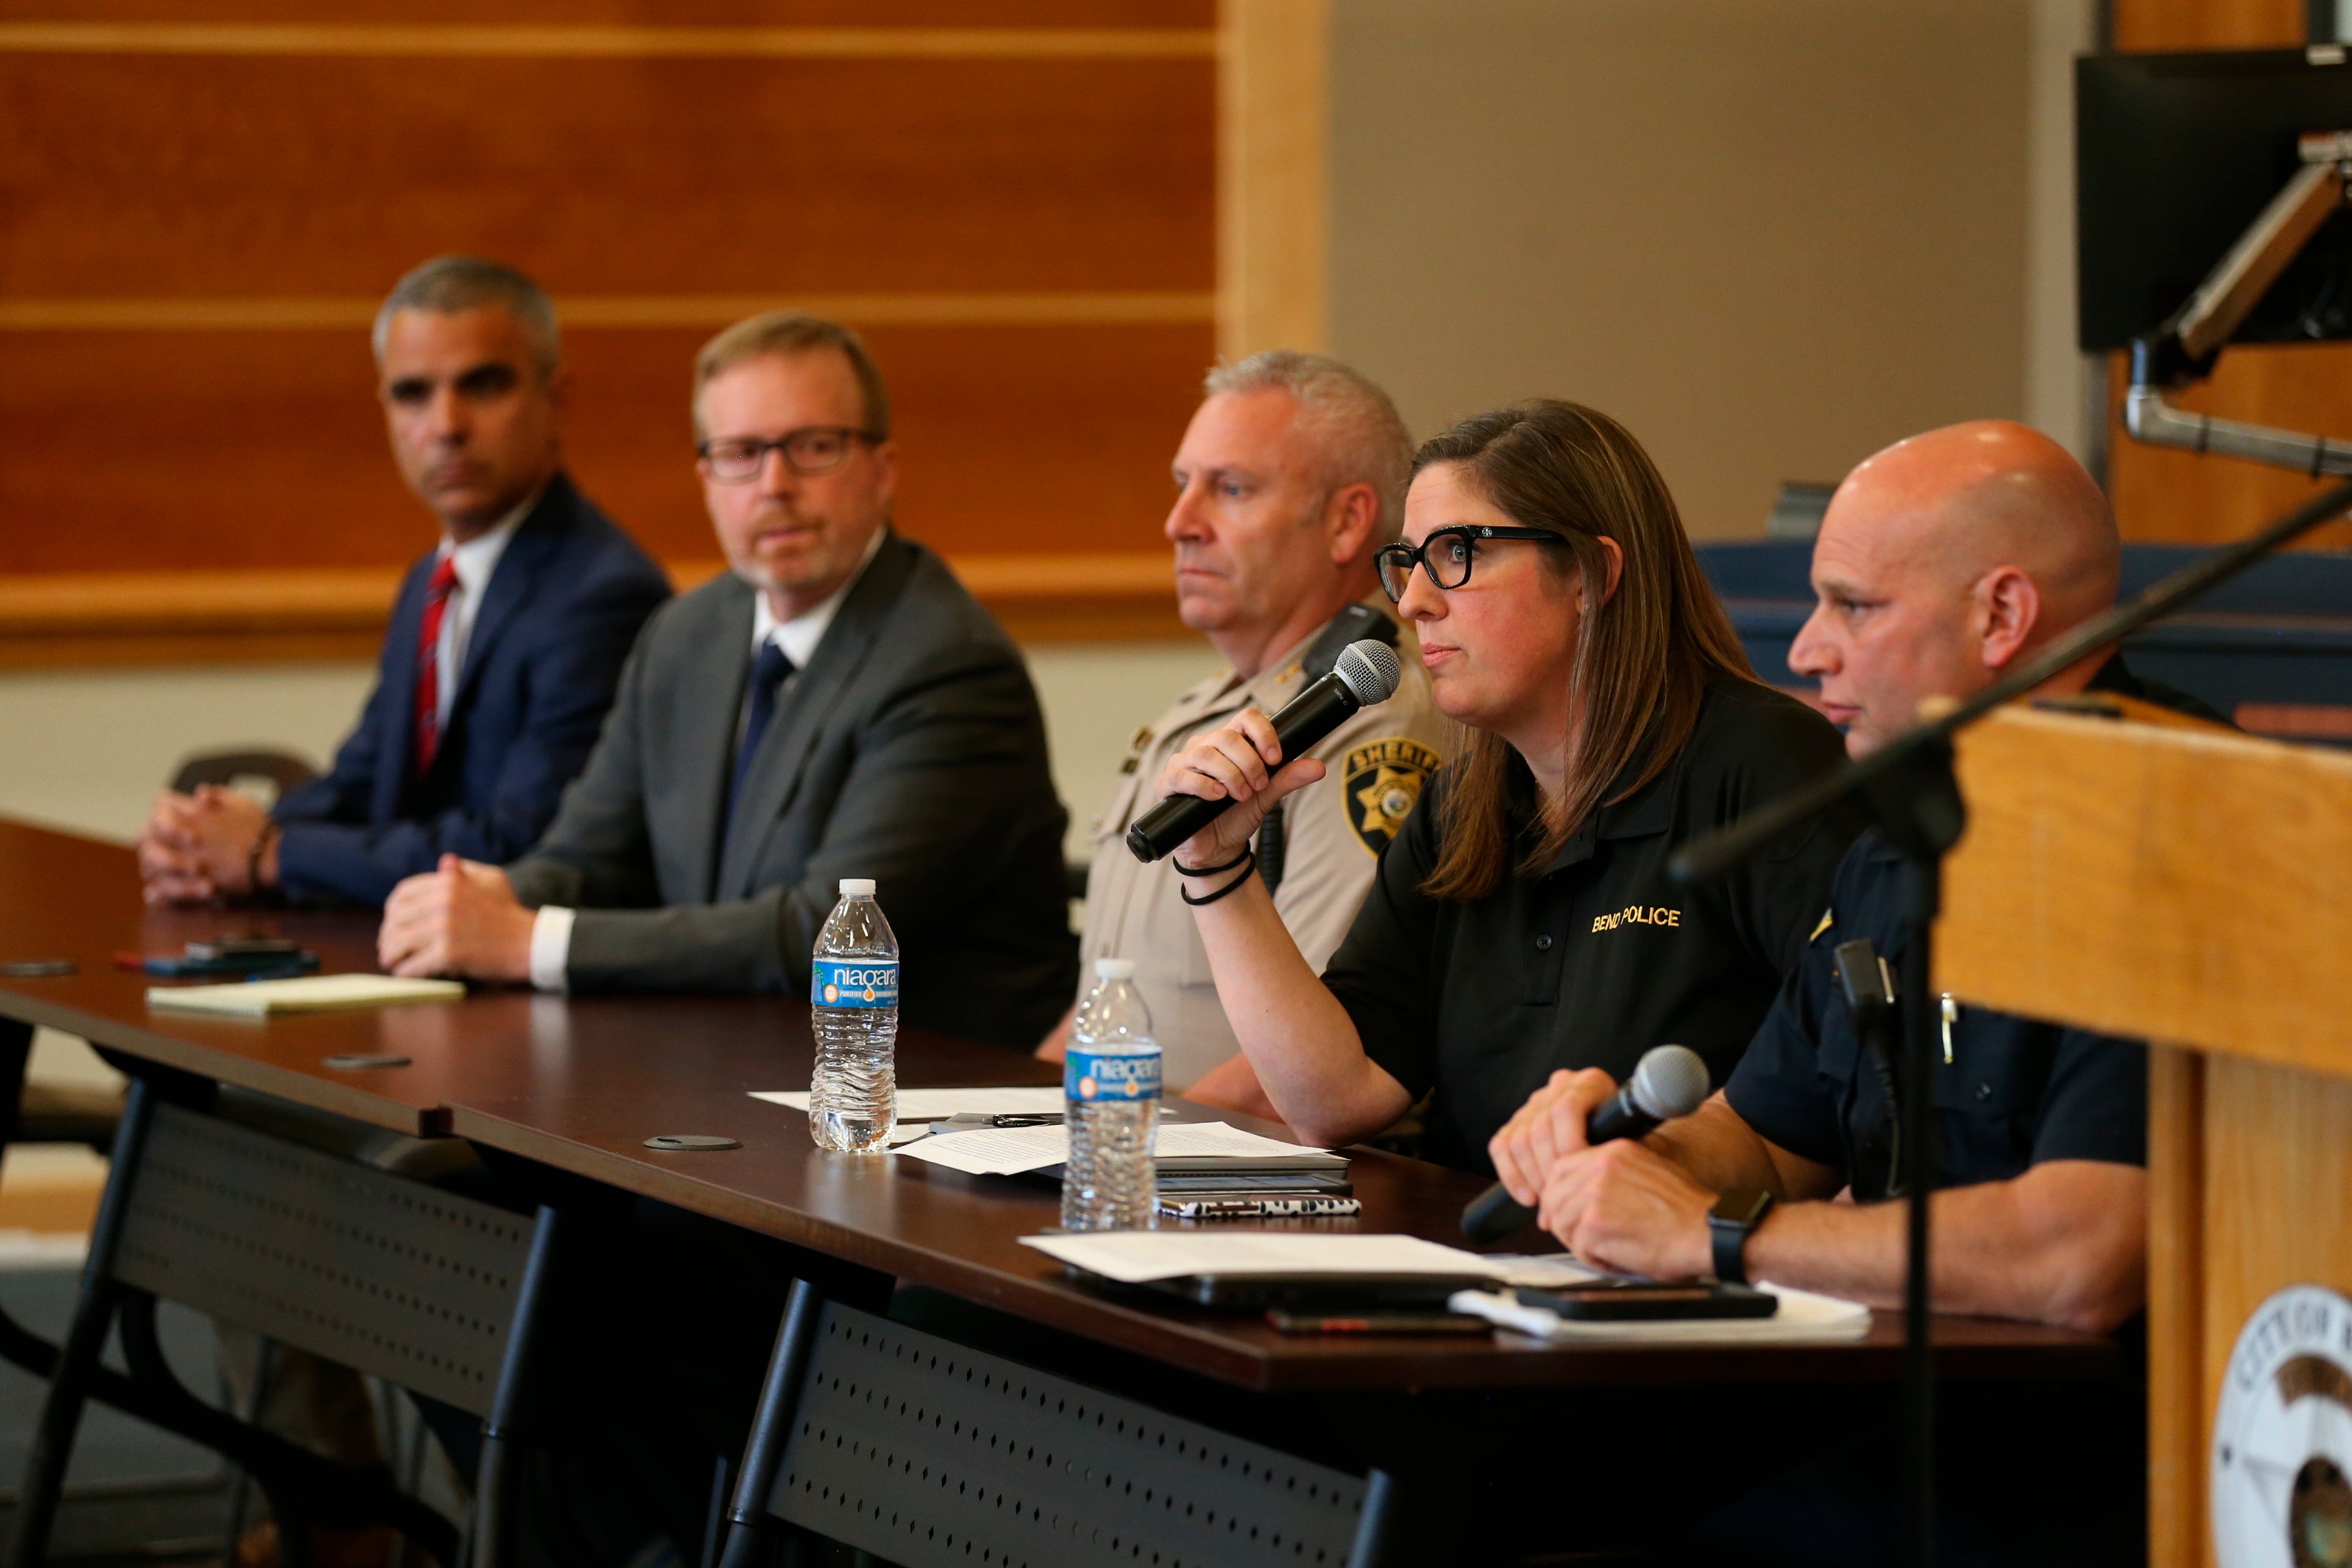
[809,877,898,1154]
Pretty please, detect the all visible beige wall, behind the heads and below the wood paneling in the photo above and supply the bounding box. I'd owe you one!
[0,0,2091,849]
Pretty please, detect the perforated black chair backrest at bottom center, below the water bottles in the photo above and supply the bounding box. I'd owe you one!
[769,1303,1378,1568]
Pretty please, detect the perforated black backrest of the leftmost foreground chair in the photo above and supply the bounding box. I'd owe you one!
[113,1105,534,1415]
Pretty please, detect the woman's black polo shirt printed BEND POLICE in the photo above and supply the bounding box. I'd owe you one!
[1324,679,1861,1171]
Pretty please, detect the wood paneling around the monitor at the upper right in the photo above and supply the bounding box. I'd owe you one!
[2108,0,2352,548]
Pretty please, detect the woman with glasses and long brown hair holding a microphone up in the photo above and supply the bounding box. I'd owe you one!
[1160,402,1861,1169]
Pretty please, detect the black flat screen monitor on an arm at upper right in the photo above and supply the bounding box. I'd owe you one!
[2074,50,2352,353]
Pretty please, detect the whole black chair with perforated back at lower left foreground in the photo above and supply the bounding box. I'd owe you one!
[0,1020,557,1568]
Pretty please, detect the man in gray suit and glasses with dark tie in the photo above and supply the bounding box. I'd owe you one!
[376,312,1077,1049]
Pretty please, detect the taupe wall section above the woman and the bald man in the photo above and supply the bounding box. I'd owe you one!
[1331,0,2041,536]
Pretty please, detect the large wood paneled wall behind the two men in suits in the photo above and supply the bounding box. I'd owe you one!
[0,0,1324,663]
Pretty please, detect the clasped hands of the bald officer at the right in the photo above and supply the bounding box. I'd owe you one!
[1486,1067,1714,1279]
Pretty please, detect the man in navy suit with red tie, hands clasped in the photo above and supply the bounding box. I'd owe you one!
[139,257,670,905]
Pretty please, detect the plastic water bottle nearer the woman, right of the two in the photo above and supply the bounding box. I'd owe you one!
[1061,959,1160,1230]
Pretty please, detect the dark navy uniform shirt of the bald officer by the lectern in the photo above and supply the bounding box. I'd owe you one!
[1724,656,2191,1201]
